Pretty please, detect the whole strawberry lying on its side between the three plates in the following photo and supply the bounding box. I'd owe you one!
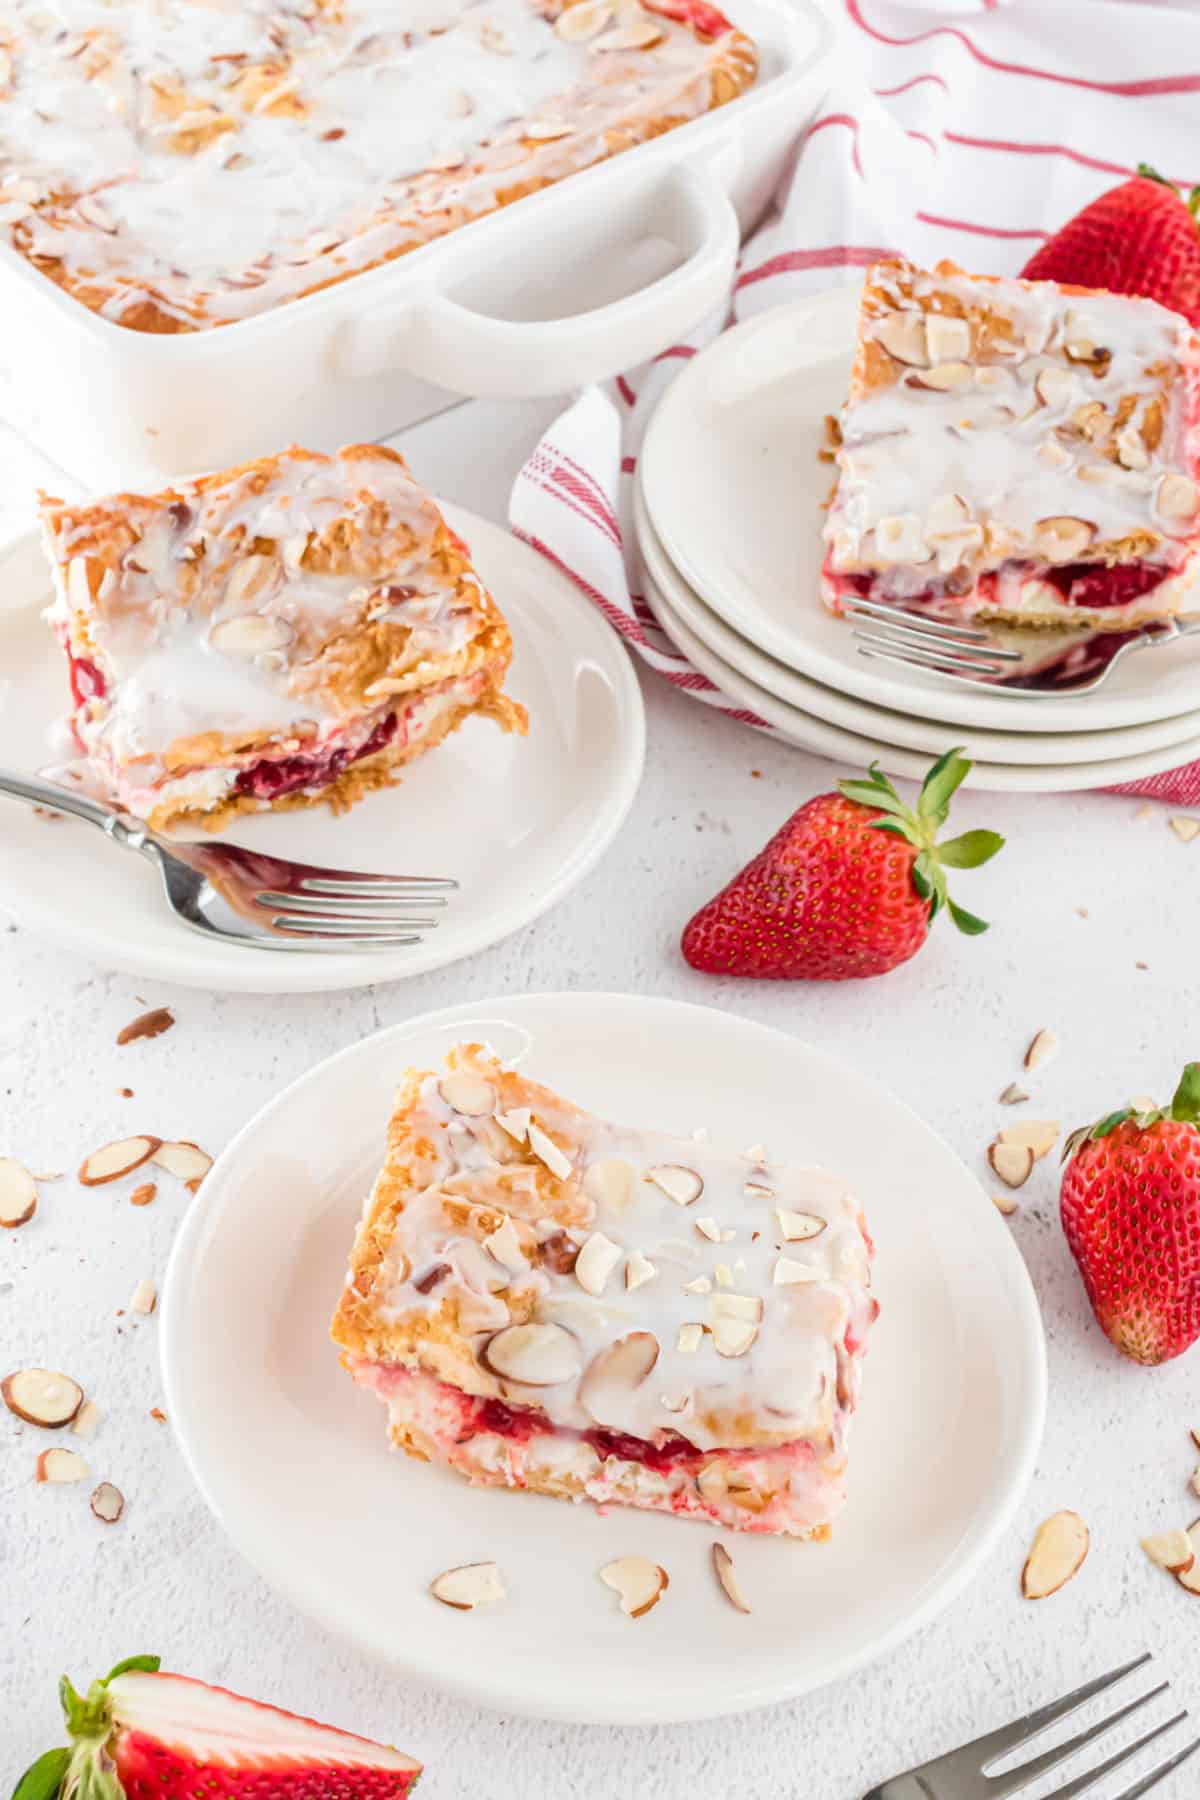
[682,751,1004,981]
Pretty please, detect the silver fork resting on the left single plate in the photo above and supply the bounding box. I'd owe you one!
[0,769,459,950]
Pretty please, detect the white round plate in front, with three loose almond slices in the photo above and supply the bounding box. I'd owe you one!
[162,994,1045,1724]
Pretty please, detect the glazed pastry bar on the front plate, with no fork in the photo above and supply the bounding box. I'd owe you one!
[333,1044,878,1537]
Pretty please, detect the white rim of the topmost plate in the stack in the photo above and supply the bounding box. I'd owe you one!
[637,291,1195,733]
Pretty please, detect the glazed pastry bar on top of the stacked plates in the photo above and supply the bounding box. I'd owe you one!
[824,261,1200,630]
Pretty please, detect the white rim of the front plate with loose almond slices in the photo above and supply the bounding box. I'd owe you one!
[158,990,1049,1726]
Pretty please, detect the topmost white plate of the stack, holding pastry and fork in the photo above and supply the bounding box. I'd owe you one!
[639,286,1200,731]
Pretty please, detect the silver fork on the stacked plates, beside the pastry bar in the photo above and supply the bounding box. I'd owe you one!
[844,596,1200,697]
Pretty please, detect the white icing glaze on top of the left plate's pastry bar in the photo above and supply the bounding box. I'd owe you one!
[47,455,482,790]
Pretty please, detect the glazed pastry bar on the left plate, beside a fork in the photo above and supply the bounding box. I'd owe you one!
[41,445,525,830]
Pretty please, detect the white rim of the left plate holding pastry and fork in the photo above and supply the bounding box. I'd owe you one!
[0,514,646,994]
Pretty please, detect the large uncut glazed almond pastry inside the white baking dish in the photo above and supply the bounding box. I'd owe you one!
[0,0,756,331]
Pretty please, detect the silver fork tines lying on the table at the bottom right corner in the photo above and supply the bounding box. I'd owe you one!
[864,1652,1200,1800]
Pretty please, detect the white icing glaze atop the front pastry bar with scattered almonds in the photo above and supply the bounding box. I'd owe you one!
[376,1076,874,1449]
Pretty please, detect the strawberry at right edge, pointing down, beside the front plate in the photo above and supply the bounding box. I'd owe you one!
[1061,1062,1200,1363]
